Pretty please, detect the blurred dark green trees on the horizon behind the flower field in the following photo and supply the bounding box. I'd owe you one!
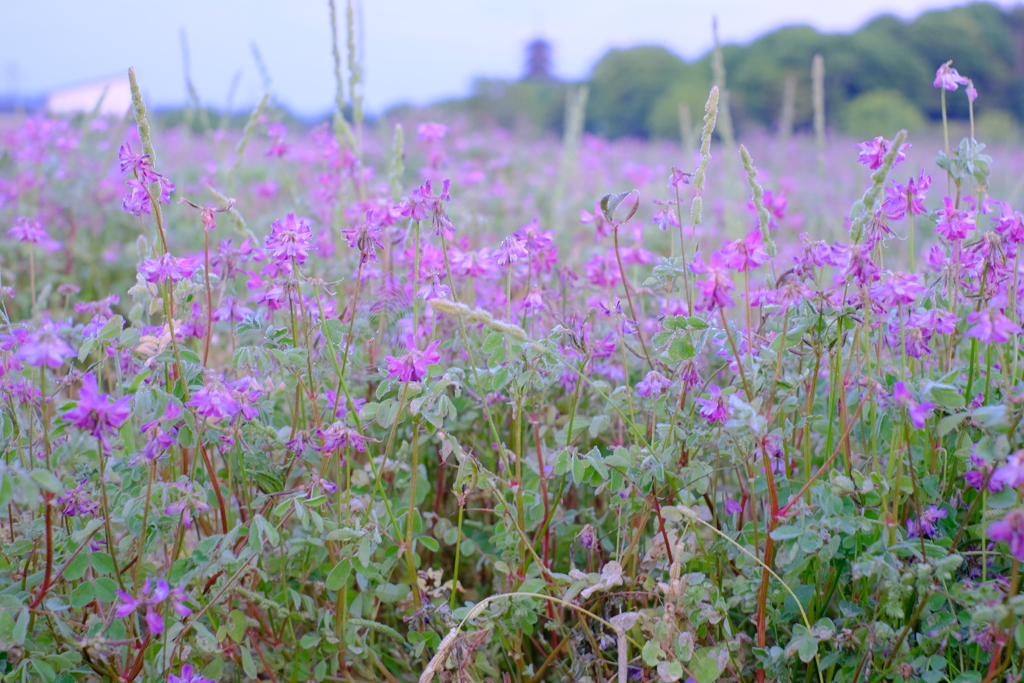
[428,2,1024,141]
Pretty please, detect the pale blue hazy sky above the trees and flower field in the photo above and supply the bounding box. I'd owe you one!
[0,0,1014,117]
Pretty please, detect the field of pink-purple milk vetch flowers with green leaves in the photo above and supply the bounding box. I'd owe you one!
[0,50,1024,683]
